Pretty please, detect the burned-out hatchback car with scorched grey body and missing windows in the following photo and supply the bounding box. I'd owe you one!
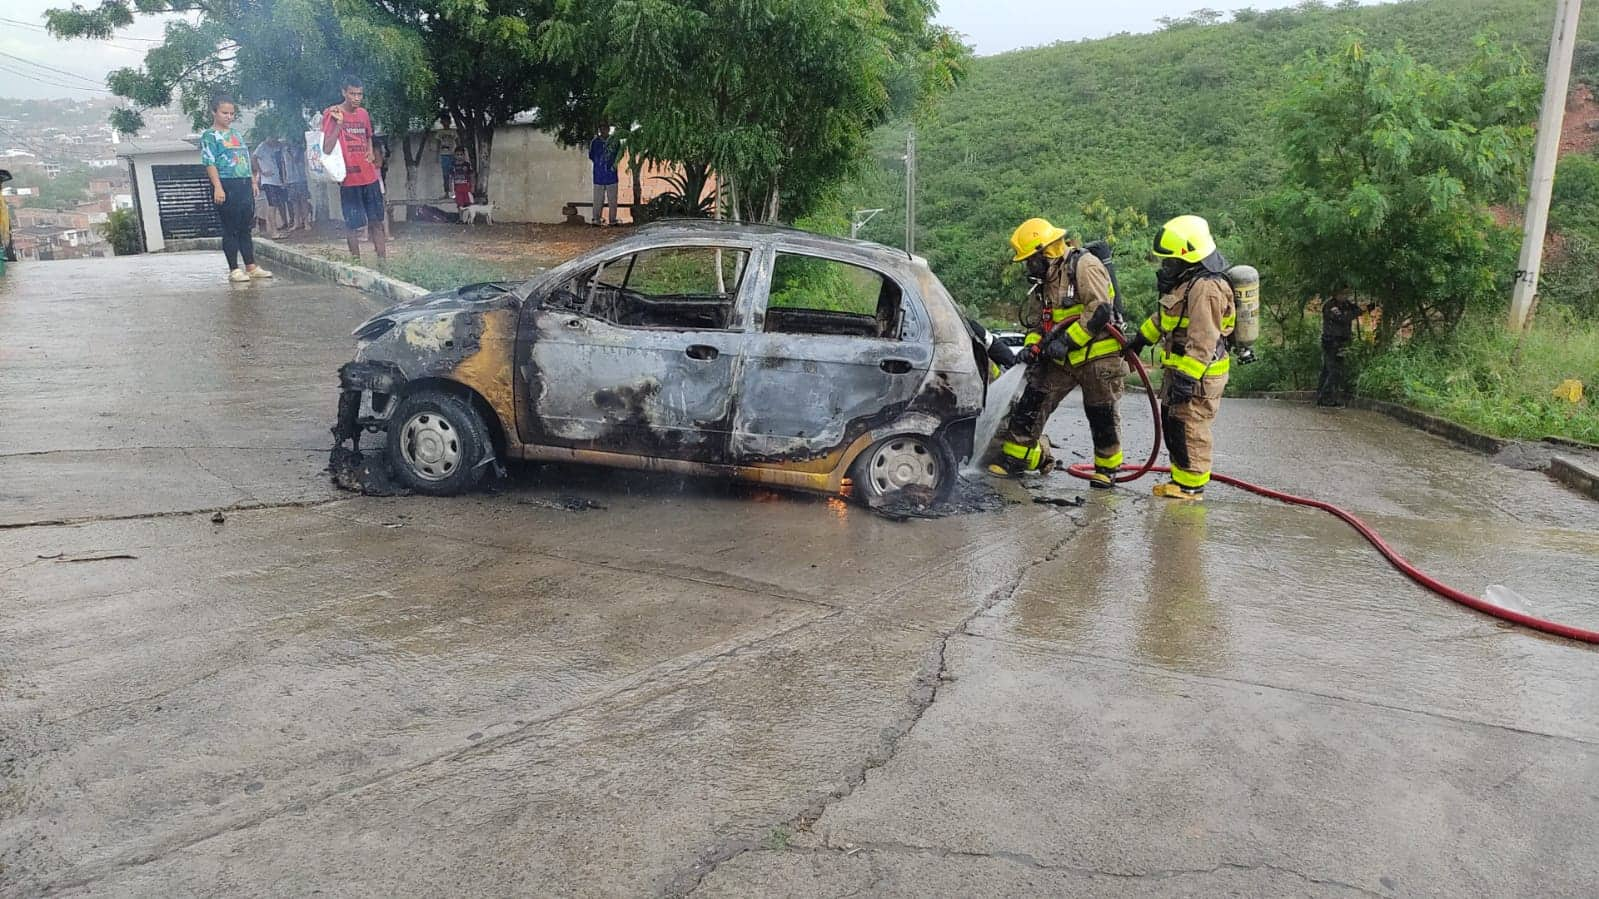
[334,222,987,501]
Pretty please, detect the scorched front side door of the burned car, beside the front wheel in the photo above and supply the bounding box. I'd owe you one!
[518,243,752,462]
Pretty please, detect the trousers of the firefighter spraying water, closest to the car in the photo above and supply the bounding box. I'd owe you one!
[988,355,1127,470]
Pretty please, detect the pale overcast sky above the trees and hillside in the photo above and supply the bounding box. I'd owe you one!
[0,0,1394,98]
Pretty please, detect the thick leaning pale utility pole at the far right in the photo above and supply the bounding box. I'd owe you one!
[1509,0,1583,331]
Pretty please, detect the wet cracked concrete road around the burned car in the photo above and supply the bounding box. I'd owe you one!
[0,254,1599,896]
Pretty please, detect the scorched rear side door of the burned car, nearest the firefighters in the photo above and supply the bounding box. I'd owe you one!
[732,246,932,470]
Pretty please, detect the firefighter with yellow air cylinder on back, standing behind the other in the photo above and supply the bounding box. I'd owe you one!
[1127,216,1236,501]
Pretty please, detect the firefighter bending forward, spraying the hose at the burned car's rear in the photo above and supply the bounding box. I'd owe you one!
[988,219,1127,488]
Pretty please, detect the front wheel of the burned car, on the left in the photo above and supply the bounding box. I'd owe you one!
[389,389,488,496]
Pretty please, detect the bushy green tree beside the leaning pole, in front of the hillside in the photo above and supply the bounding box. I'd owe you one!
[1262,36,1540,342]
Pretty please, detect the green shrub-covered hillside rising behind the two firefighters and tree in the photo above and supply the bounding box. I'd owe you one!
[846,0,1599,318]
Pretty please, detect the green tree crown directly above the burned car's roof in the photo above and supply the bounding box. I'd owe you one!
[540,0,969,221]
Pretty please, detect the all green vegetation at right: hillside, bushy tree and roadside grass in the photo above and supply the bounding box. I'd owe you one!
[839,0,1599,440]
